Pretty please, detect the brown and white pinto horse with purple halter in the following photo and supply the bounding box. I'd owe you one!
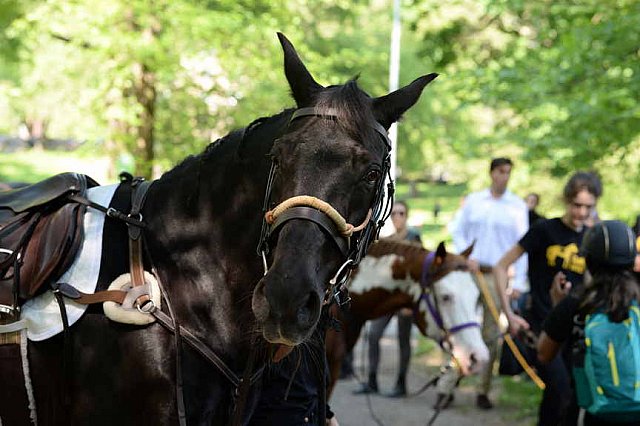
[326,239,489,395]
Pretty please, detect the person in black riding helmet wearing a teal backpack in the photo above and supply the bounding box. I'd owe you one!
[538,220,640,426]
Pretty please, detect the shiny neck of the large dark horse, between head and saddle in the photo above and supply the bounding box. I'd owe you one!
[143,122,278,354]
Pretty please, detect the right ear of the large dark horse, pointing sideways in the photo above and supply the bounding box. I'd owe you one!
[373,73,438,130]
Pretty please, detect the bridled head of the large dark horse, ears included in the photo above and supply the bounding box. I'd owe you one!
[252,34,436,346]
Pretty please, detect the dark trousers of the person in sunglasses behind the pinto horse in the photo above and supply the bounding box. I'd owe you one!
[369,314,413,379]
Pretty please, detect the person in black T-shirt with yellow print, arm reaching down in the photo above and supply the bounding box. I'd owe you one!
[494,172,602,425]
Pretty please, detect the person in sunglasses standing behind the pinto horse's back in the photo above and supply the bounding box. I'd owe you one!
[354,201,422,398]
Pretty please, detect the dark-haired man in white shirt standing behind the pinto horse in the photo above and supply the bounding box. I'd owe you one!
[450,157,529,409]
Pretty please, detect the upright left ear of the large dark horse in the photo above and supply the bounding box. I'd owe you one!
[278,33,323,108]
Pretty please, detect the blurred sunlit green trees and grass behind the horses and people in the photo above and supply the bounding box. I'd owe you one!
[0,0,640,247]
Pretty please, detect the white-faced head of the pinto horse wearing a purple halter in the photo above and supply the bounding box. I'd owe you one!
[421,243,489,374]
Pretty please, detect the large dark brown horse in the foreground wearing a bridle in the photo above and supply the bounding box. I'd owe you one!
[0,35,435,425]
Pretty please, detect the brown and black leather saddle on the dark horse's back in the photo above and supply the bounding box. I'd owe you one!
[0,173,98,316]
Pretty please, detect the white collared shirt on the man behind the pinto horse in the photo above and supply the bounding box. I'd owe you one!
[449,189,529,291]
